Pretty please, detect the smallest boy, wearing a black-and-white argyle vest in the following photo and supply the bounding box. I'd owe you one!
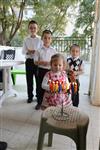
[67,44,84,107]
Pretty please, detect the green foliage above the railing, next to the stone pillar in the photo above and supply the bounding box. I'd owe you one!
[73,0,95,36]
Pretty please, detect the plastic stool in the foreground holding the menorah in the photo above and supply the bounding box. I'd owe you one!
[37,106,89,150]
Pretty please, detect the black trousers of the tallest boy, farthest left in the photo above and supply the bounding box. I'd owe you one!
[25,58,38,100]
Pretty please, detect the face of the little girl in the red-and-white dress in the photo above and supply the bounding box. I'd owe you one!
[51,59,64,72]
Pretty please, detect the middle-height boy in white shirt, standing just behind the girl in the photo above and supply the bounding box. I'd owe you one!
[35,30,56,110]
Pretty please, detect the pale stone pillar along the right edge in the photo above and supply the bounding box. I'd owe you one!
[89,0,100,106]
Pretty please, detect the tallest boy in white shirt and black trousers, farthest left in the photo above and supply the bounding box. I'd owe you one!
[22,20,42,103]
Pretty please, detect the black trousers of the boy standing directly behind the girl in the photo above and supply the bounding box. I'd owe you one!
[37,68,49,105]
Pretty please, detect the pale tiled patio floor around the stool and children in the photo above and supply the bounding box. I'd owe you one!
[0,62,100,150]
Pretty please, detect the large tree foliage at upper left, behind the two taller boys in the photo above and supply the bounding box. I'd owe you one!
[0,0,78,45]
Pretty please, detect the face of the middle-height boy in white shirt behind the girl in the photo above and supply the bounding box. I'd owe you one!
[42,33,52,47]
